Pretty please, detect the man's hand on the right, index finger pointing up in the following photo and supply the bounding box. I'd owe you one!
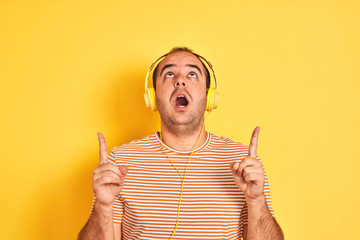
[230,127,265,201]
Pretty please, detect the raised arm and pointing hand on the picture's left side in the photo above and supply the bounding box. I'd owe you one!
[78,133,128,240]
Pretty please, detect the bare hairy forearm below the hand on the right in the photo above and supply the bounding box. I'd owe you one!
[246,198,284,240]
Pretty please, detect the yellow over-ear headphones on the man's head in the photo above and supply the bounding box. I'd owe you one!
[144,52,219,112]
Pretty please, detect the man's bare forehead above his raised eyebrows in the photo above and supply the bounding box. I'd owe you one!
[158,51,204,71]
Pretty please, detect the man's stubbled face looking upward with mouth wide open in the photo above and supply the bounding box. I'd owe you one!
[156,51,206,131]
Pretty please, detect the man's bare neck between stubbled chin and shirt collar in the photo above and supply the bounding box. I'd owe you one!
[161,122,207,151]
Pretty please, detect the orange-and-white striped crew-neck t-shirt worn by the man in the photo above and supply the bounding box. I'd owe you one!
[109,133,274,240]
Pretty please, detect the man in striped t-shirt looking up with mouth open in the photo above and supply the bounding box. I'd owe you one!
[79,48,284,240]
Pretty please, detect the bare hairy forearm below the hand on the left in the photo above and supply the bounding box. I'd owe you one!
[78,202,115,240]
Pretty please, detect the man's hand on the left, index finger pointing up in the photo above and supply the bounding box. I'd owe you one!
[93,133,128,206]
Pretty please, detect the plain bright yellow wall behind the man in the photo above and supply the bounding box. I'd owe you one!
[0,0,360,240]
